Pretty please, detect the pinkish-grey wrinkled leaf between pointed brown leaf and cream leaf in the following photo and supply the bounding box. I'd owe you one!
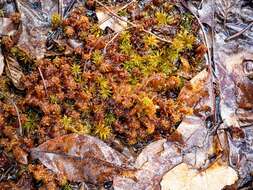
[113,139,182,190]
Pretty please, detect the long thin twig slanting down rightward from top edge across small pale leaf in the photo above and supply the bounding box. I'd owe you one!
[95,0,171,43]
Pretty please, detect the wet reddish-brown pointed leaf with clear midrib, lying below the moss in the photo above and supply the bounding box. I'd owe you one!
[32,134,135,185]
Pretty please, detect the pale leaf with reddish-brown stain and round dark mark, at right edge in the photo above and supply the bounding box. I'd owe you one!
[219,51,253,127]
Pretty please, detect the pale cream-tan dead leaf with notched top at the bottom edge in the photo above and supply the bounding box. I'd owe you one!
[161,162,238,190]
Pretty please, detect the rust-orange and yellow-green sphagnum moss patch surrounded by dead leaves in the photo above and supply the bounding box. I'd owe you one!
[0,0,206,188]
